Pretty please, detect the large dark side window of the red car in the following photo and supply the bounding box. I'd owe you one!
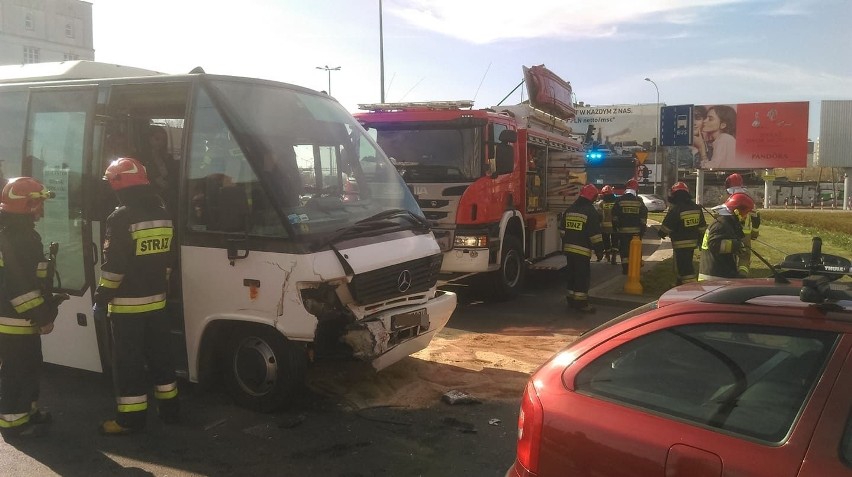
[575,323,838,443]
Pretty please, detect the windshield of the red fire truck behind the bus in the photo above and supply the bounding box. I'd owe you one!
[368,123,483,183]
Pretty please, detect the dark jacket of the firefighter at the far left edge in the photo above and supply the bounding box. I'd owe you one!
[0,212,59,335]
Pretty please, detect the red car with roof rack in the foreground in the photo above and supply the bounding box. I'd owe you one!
[507,270,852,477]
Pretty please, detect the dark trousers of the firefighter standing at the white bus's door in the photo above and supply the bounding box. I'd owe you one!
[110,309,180,429]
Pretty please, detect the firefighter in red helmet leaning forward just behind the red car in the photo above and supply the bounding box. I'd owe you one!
[698,192,754,281]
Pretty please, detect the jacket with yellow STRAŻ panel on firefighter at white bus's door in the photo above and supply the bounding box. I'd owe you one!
[95,187,174,313]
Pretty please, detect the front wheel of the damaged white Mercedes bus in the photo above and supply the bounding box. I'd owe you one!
[222,325,307,412]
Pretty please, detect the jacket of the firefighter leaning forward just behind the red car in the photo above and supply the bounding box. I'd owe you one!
[698,214,745,278]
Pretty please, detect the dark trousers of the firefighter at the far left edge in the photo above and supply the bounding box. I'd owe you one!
[0,333,42,429]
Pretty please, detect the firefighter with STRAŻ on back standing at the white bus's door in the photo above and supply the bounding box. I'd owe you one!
[95,158,179,435]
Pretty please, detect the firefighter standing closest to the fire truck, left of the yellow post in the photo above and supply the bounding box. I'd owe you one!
[559,184,603,313]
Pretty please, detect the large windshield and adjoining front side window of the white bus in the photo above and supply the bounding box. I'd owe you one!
[193,79,423,246]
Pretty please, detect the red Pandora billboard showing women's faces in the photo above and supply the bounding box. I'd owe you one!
[691,101,808,169]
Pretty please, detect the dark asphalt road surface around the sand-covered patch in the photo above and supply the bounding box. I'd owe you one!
[0,263,644,477]
